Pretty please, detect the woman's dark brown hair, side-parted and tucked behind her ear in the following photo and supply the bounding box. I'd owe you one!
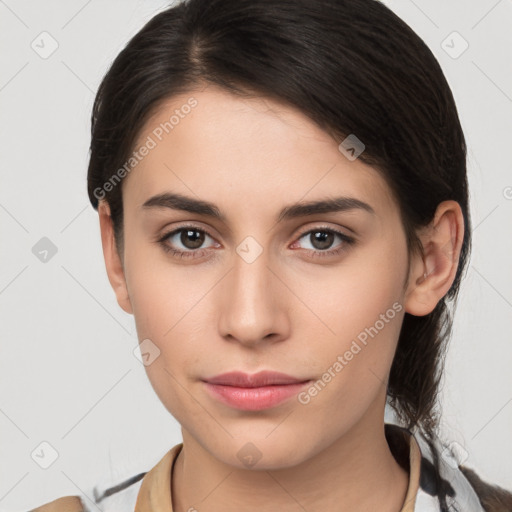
[88,0,471,508]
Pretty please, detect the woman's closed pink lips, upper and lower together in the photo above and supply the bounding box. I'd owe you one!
[203,371,311,411]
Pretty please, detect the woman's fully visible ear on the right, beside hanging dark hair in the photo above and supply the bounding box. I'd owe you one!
[404,200,464,316]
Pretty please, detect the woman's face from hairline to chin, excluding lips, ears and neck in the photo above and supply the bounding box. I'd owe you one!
[99,86,416,468]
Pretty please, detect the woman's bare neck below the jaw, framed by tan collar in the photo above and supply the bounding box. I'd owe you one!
[172,402,409,512]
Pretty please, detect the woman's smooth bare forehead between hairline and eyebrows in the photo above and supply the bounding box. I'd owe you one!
[123,86,396,218]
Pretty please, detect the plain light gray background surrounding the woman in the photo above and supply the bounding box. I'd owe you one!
[0,0,512,512]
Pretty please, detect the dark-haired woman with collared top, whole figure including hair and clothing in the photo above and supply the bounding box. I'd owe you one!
[30,0,512,512]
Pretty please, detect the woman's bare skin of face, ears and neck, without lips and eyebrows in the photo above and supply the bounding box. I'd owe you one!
[99,82,464,512]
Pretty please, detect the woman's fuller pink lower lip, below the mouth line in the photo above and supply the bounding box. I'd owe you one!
[204,381,310,411]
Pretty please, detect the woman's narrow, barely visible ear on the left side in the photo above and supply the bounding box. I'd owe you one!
[98,201,133,314]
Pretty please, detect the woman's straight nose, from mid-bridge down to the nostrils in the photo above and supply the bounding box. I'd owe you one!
[218,250,290,347]
